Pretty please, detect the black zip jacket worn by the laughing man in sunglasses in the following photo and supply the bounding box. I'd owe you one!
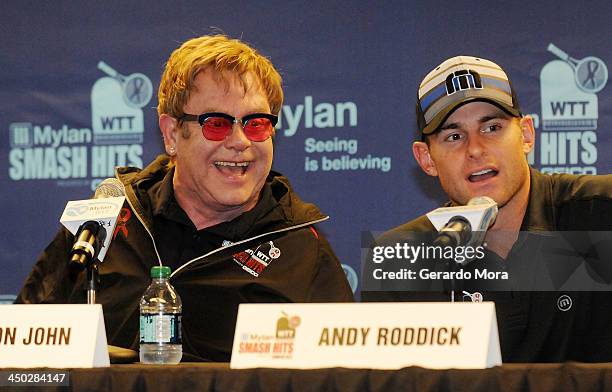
[16,155,353,361]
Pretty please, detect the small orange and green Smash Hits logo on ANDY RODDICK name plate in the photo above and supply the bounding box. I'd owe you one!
[238,312,302,359]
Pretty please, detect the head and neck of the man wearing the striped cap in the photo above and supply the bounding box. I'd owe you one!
[412,56,532,257]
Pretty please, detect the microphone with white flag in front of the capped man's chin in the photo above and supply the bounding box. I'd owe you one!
[427,196,498,247]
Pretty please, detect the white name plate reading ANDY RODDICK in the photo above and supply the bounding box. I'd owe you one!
[230,302,502,369]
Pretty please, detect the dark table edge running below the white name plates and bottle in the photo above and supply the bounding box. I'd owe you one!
[0,362,612,392]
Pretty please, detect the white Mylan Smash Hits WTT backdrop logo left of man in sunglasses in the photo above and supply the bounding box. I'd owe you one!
[8,61,153,189]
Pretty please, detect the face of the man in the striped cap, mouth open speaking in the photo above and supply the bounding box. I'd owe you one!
[413,102,534,208]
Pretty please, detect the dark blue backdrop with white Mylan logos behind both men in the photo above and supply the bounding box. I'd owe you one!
[0,0,612,301]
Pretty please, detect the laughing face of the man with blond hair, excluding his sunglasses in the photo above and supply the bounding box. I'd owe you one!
[159,68,273,229]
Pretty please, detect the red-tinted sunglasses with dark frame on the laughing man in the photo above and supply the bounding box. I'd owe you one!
[179,112,278,142]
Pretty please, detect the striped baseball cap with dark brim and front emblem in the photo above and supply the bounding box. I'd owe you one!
[416,56,521,135]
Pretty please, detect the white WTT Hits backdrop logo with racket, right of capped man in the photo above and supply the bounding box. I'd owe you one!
[536,43,608,174]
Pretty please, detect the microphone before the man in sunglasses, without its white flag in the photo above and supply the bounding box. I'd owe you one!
[70,178,125,268]
